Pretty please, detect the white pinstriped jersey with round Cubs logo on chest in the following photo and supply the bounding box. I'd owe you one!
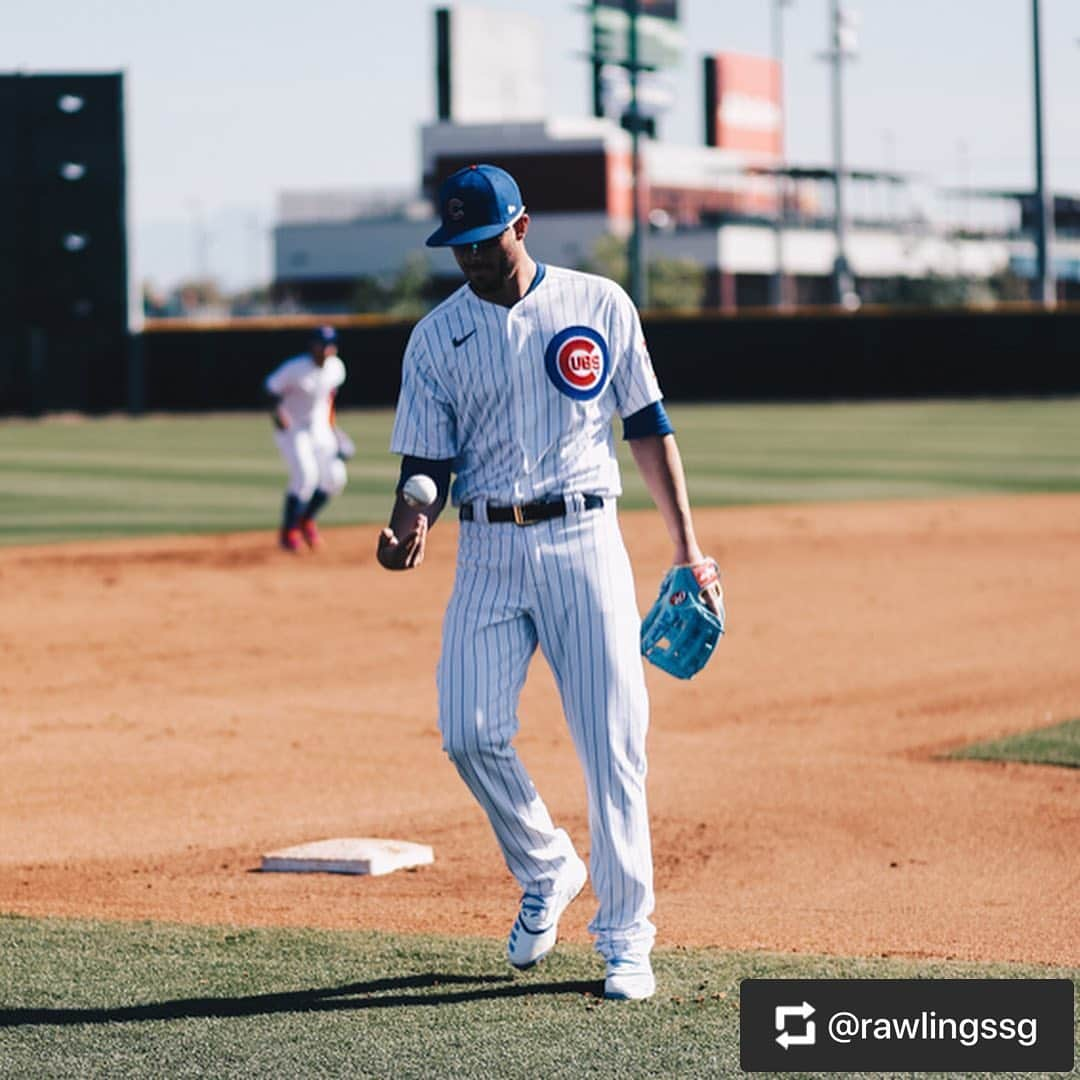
[390,264,662,504]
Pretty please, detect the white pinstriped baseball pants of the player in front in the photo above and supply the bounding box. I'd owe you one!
[437,496,656,959]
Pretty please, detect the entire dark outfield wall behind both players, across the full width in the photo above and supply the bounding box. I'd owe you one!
[0,305,1080,415]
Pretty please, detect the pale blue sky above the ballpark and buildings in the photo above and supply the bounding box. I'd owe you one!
[0,0,1080,287]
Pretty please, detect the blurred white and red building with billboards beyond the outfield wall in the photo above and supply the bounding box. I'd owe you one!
[273,0,1080,311]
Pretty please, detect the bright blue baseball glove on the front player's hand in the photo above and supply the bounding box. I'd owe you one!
[642,558,724,678]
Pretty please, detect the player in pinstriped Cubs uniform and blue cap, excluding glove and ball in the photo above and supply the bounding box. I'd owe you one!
[377,164,721,999]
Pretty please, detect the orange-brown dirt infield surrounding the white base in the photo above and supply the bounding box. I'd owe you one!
[0,496,1080,964]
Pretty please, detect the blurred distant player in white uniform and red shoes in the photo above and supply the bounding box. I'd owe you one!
[266,326,354,552]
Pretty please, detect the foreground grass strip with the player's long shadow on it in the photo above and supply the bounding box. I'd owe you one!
[0,917,1080,1080]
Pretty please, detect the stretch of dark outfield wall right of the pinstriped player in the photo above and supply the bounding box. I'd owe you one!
[646,306,1080,401]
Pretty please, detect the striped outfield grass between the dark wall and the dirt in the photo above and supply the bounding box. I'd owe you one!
[0,399,1080,544]
